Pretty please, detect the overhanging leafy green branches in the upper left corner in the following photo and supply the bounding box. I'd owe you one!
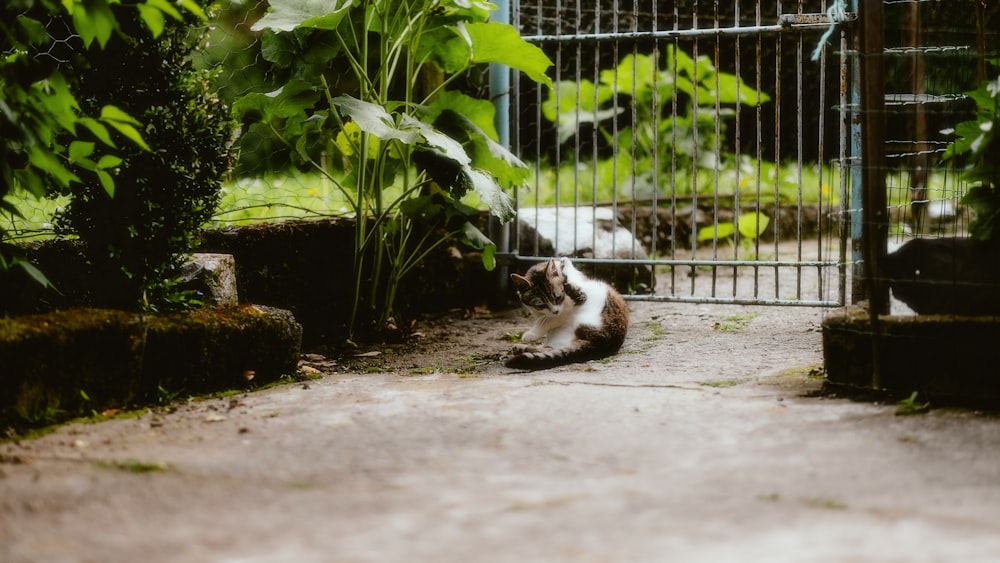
[0,0,203,284]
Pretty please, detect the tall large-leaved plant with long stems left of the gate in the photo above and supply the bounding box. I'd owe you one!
[235,0,551,338]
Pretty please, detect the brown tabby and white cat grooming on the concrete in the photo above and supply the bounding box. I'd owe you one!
[506,257,629,369]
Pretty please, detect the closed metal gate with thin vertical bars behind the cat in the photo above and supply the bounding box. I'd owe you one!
[509,0,853,306]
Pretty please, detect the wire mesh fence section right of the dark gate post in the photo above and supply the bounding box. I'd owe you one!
[864,1,1000,314]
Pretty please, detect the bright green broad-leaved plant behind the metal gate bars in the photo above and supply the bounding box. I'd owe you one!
[542,45,770,200]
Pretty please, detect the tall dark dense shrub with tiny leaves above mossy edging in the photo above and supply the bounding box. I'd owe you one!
[56,2,232,310]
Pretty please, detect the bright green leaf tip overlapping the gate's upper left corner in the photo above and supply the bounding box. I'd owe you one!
[459,22,552,86]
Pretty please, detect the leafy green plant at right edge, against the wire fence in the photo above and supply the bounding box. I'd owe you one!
[944,70,1000,240]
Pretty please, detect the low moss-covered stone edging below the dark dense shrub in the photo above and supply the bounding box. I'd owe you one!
[0,305,302,427]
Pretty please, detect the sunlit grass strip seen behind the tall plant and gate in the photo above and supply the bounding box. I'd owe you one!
[0,156,852,240]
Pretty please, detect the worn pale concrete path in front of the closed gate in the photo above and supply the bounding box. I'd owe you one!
[0,303,1000,563]
